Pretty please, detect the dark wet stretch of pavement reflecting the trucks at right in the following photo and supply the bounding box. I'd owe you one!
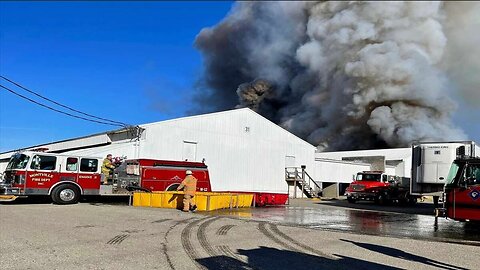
[206,200,480,246]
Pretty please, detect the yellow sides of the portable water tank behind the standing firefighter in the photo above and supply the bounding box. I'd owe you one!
[129,191,253,211]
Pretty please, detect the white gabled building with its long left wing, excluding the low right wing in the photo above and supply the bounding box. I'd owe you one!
[0,108,315,198]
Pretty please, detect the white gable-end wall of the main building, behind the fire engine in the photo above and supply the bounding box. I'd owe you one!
[136,109,315,193]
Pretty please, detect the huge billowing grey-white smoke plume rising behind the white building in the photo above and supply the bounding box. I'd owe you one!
[196,1,472,150]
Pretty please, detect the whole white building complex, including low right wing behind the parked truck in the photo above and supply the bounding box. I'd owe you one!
[0,108,411,197]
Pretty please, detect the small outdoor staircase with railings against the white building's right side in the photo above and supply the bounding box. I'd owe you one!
[285,166,322,198]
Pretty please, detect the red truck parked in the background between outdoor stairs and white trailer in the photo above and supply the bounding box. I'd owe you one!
[345,171,417,204]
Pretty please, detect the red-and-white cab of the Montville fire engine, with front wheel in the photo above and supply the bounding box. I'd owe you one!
[0,151,103,204]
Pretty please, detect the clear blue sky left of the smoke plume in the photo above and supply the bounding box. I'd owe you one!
[0,1,480,152]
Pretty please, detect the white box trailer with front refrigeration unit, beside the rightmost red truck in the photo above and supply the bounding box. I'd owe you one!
[410,141,480,204]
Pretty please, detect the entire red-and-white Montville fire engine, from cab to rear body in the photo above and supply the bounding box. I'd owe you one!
[0,151,211,204]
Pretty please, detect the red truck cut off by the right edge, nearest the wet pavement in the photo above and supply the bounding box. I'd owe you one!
[435,156,480,226]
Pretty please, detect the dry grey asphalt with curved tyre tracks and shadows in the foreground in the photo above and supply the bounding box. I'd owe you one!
[0,197,480,269]
